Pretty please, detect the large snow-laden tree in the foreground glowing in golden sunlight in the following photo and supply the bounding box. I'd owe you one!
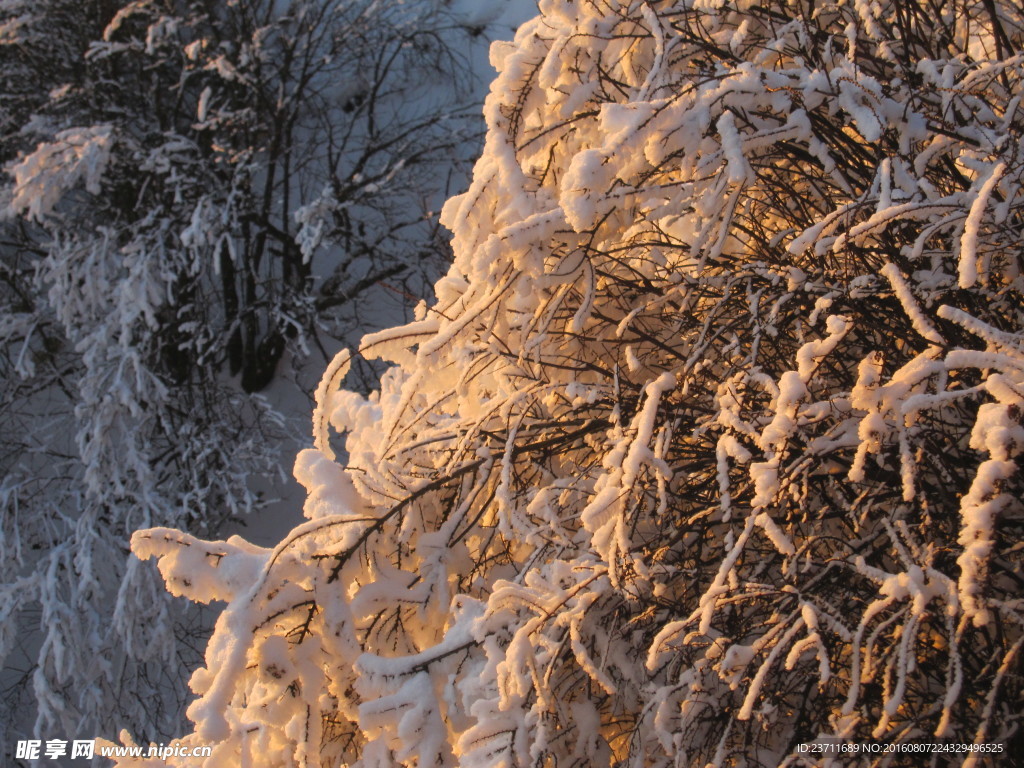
[125,0,1024,768]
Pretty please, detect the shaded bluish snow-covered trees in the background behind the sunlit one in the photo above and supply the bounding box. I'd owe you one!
[0,0,487,745]
